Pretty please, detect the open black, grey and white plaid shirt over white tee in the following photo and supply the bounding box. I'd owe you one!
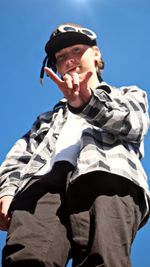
[0,82,150,215]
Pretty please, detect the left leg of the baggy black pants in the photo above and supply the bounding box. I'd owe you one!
[2,162,72,267]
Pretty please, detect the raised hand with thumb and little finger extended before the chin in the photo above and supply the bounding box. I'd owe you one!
[44,67,92,107]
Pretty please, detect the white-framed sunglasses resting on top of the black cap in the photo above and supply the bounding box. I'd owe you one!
[52,24,97,40]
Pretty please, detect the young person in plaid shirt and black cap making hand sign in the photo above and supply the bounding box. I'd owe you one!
[0,23,149,267]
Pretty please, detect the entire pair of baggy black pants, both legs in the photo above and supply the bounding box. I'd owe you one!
[2,163,143,267]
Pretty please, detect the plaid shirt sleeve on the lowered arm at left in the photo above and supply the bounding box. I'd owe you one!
[0,111,52,197]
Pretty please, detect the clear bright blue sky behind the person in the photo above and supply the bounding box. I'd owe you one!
[0,0,150,267]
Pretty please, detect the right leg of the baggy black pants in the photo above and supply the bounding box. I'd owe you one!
[67,172,145,267]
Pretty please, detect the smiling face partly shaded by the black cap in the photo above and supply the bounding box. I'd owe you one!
[55,44,100,78]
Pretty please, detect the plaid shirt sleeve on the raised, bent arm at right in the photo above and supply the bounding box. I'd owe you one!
[71,86,149,143]
